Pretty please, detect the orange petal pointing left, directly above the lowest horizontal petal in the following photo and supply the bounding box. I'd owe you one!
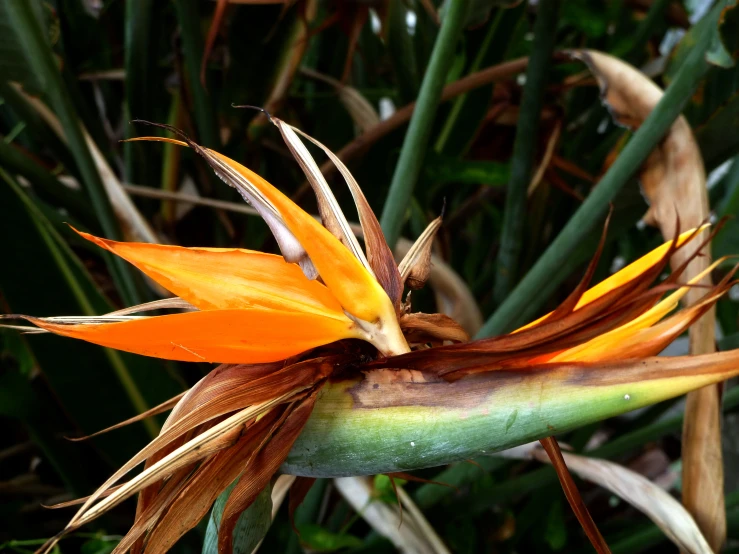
[72,227,343,317]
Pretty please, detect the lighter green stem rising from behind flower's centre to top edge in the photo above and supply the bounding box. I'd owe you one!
[380,0,470,248]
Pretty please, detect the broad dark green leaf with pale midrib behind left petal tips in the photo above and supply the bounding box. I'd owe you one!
[0,169,182,464]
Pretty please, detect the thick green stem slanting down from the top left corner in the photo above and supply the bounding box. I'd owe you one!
[6,2,139,304]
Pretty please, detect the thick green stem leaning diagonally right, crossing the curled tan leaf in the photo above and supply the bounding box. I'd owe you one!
[478,11,712,337]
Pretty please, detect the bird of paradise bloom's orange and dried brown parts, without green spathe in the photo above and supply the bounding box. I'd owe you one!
[2,118,739,554]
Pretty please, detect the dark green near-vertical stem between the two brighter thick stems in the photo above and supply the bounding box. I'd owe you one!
[493,0,559,304]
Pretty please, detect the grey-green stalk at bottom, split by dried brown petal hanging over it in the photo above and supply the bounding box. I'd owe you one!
[203,479,272,554]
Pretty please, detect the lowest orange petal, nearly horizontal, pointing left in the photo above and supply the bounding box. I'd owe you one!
[26,309,357,364]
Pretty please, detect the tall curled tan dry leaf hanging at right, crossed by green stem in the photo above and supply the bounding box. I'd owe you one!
[571,50,726,550]
